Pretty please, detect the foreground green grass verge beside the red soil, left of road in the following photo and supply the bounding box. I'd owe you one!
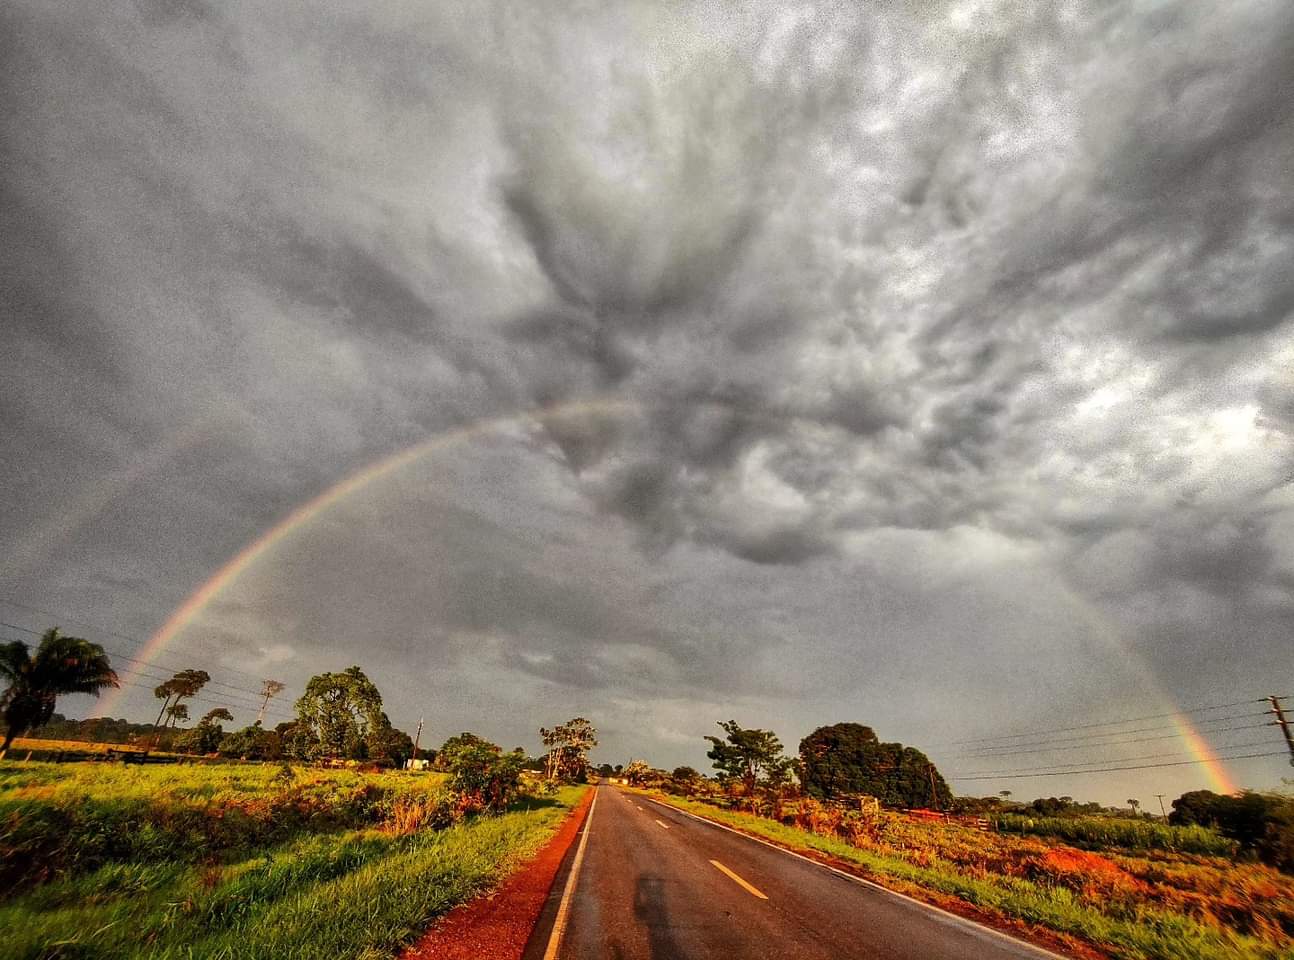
[0,765,584,960]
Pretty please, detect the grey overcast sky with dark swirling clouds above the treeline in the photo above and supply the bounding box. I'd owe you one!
[0,0,1294,803]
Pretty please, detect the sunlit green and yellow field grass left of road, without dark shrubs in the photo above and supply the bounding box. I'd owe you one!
[0,765,582,960]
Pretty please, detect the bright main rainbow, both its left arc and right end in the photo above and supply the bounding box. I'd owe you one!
[97,397,1237,793]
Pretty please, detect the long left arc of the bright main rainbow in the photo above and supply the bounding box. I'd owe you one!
[96,398,639,717]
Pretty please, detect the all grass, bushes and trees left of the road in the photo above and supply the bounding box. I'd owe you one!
[0,631,597,960]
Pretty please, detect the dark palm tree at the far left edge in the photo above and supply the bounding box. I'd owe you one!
[0,626,120,758]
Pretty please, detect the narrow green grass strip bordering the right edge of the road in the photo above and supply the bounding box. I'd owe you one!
[660,796,1294,960]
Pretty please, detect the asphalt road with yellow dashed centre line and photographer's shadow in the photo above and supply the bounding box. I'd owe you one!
[525,787,1055,960]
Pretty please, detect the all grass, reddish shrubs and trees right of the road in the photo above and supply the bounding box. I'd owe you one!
[634,722,1294,960]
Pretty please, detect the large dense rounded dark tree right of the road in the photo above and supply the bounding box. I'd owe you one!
[800,723,952,809]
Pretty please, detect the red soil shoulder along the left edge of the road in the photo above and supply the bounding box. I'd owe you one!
[401,791,593,960]
